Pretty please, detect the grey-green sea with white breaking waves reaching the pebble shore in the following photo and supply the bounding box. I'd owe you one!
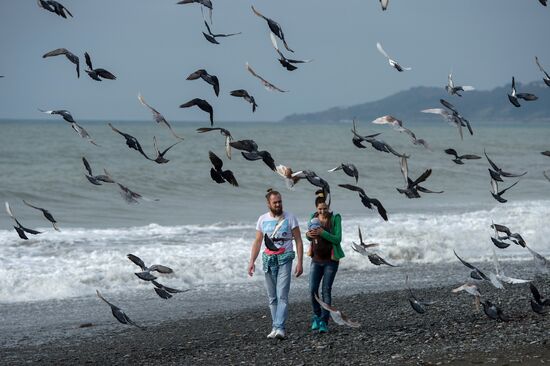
[0,116,550,346]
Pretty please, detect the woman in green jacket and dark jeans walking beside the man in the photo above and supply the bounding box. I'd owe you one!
[306,191,344,333]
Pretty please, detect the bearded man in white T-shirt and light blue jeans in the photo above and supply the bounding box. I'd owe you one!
[248,189,304,339]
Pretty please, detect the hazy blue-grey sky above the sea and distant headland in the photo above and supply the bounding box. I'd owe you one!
[0,0,550,123]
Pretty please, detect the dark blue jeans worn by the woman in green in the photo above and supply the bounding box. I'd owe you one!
[309,261,339,322]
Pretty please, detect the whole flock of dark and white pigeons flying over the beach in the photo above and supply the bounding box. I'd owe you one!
[0,0,550,329]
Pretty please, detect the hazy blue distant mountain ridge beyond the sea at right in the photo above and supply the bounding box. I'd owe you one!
[282,81,550,122]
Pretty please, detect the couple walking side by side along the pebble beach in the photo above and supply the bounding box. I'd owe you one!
[248,189,344,339]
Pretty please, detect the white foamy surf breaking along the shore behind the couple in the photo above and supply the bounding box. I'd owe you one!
[0,201,550,302]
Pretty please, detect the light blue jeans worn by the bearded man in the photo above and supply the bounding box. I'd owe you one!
[265,261,292,330]
